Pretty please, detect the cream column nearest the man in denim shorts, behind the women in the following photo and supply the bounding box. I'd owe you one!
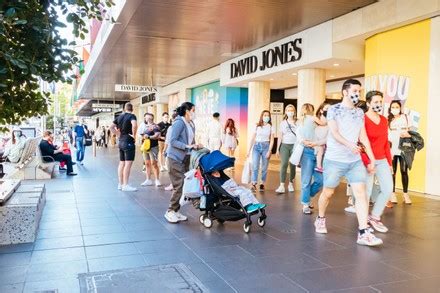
[298,68,326,113]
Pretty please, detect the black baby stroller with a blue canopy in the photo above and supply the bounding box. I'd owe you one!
[199,151,267,233]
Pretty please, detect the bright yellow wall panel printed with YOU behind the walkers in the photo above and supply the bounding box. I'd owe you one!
[365,20,431,192]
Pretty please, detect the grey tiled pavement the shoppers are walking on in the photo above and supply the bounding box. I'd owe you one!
[0,149,440,293]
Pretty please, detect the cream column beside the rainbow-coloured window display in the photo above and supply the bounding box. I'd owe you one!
[248,81,270,152]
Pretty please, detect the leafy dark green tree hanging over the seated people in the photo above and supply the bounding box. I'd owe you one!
[0,0,114,125]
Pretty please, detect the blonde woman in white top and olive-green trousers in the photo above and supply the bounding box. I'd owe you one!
[275,104,296,194]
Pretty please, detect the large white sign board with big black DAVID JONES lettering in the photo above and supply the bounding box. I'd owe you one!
[220,21,333,86]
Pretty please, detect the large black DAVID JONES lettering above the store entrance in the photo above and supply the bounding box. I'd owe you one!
[231,38,302,78]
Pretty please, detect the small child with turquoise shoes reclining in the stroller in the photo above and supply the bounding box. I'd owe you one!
[211,171,266,213]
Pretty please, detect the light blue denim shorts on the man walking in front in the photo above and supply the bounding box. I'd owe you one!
[323,159,368,188]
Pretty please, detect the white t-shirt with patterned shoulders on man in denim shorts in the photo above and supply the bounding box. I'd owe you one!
[325,103,365,163]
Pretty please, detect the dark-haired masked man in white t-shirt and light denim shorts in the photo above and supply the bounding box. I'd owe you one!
[315,79,382,246]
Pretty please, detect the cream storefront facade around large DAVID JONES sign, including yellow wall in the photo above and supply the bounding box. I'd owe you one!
[160,0,440,195]
